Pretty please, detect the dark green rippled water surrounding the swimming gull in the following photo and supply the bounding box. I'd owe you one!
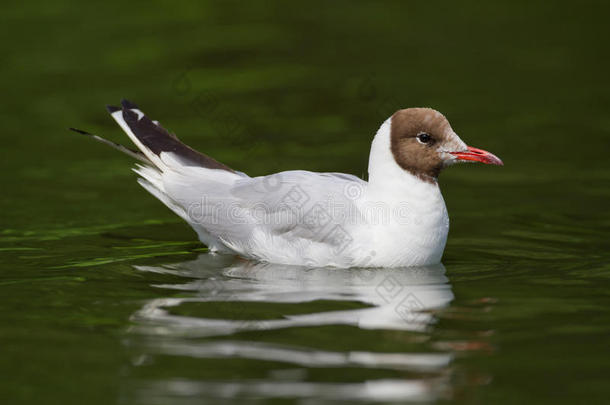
[0,1,610,404]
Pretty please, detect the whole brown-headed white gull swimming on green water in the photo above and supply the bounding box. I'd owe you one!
[71,100,503,267]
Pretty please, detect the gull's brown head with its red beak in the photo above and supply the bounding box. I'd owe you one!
[390,108,503,182]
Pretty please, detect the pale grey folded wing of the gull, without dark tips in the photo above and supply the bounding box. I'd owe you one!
[164,171,366,260]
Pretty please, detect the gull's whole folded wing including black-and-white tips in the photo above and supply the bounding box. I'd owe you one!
[76,100,366,263]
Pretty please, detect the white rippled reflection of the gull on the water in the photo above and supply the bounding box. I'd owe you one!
[121,254,453,403]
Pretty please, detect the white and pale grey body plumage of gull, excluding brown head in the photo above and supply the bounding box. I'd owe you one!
[132,117,449,267]
